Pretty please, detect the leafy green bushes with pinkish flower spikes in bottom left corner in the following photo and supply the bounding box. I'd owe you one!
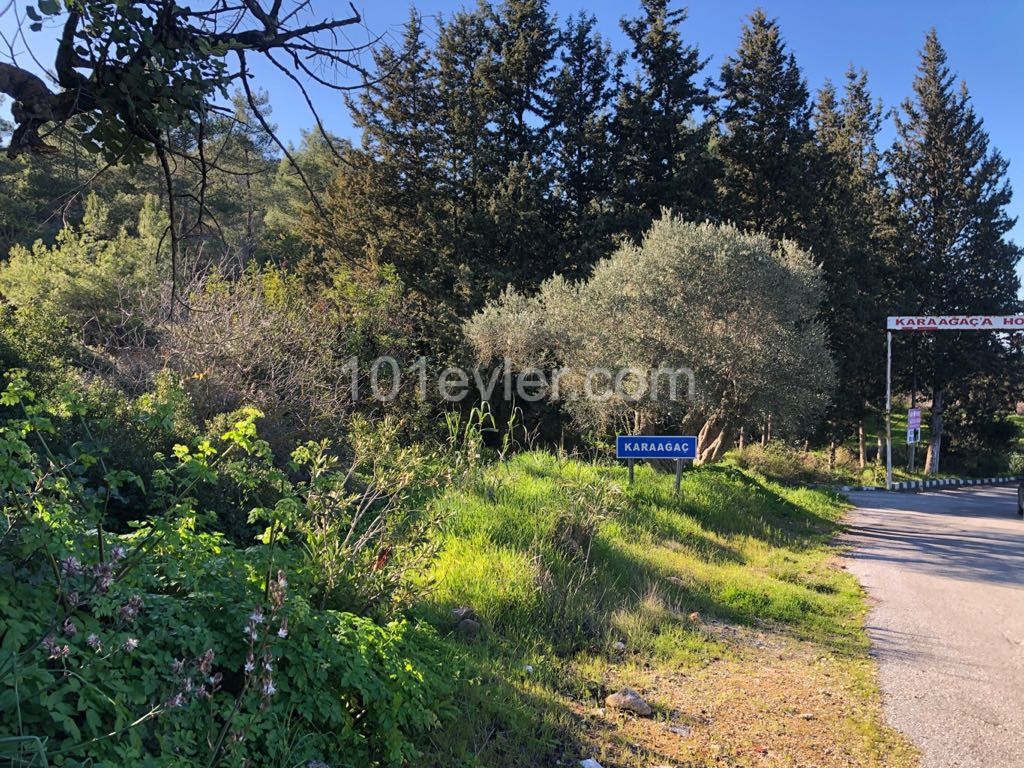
[0,376,456,768]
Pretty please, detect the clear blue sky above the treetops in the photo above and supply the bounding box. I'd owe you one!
[0,0,1024,286]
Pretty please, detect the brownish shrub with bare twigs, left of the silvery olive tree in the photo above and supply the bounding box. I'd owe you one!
[162,268,428,459]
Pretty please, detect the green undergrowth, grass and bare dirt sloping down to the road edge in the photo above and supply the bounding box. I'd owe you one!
[0,377,902,768]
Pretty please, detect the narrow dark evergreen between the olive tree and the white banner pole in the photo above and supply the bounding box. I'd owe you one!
[813,68,894,467]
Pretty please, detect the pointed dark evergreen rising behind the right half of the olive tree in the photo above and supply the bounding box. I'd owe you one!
[717,10,814,247]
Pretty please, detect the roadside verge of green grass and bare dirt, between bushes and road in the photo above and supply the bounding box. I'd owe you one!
[423,453,913,767]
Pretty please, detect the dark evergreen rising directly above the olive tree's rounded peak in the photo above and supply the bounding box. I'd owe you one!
[612,0,713,237]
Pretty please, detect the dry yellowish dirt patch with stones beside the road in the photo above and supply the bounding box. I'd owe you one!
[562,625,918,768]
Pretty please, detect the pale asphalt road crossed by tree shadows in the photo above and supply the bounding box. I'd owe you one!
[847,487,1024,768]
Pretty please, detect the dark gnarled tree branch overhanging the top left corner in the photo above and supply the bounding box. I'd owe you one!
[0,0,370,157]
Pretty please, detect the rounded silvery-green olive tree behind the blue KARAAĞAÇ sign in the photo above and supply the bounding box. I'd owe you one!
[465,212,835,462]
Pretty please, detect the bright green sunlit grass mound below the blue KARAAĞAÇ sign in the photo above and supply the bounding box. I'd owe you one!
[415,453,867,765]
